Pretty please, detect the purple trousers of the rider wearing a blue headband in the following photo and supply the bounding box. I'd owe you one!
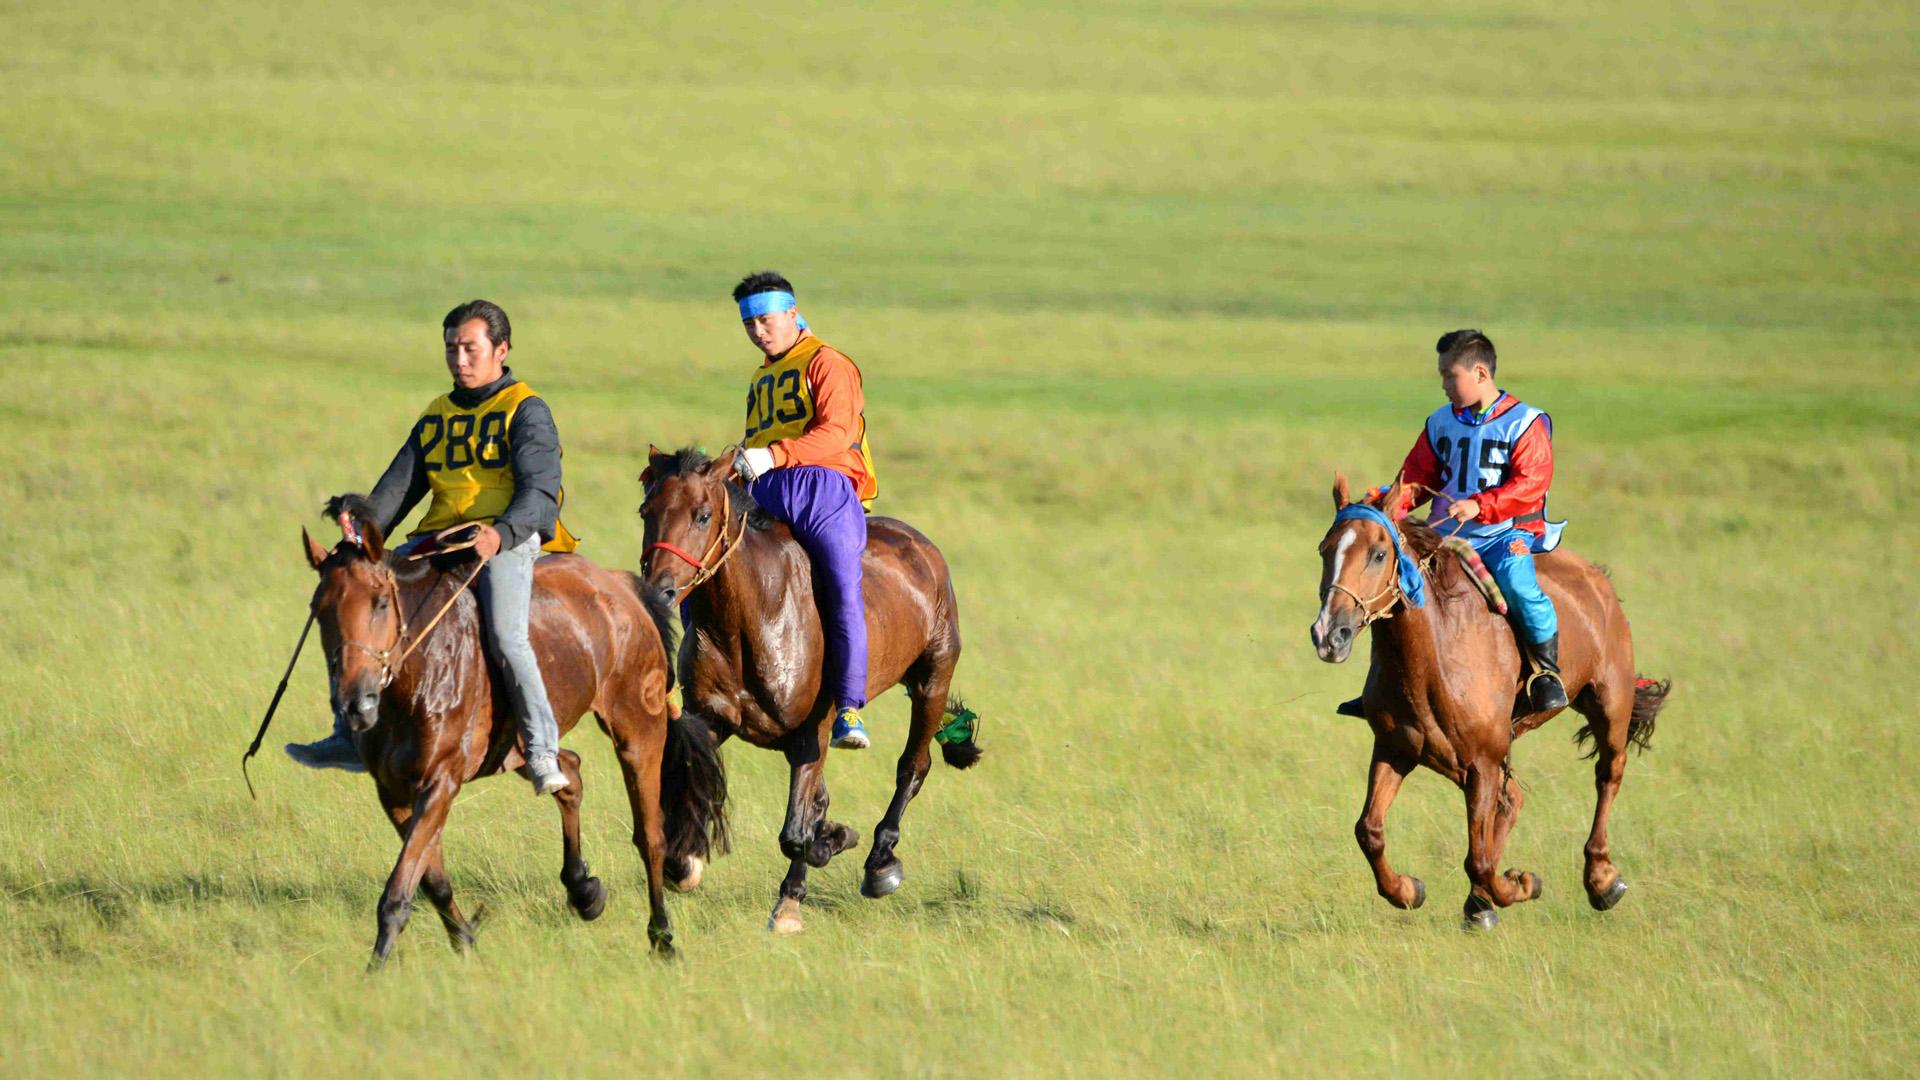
[749,465,866,709]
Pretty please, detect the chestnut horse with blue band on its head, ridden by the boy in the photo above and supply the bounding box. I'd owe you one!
[1311,477,1668,928]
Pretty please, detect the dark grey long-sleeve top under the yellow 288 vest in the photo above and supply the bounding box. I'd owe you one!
[367,367,561,548]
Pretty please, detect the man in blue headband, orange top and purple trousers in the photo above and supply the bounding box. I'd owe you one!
[733,271,879,749]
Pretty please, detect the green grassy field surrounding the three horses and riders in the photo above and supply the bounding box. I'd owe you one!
[0,0,1920,1076]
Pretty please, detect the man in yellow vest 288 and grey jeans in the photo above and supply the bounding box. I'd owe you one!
[286,300,578,796]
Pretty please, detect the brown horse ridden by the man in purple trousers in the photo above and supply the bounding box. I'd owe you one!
[639,448,981,932]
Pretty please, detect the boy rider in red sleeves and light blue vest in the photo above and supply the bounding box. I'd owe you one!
[1338,331,1567,717]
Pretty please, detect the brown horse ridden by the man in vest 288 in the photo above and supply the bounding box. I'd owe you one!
[300,496,726,967]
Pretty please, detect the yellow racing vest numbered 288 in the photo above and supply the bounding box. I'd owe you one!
[411,382,580,552]
